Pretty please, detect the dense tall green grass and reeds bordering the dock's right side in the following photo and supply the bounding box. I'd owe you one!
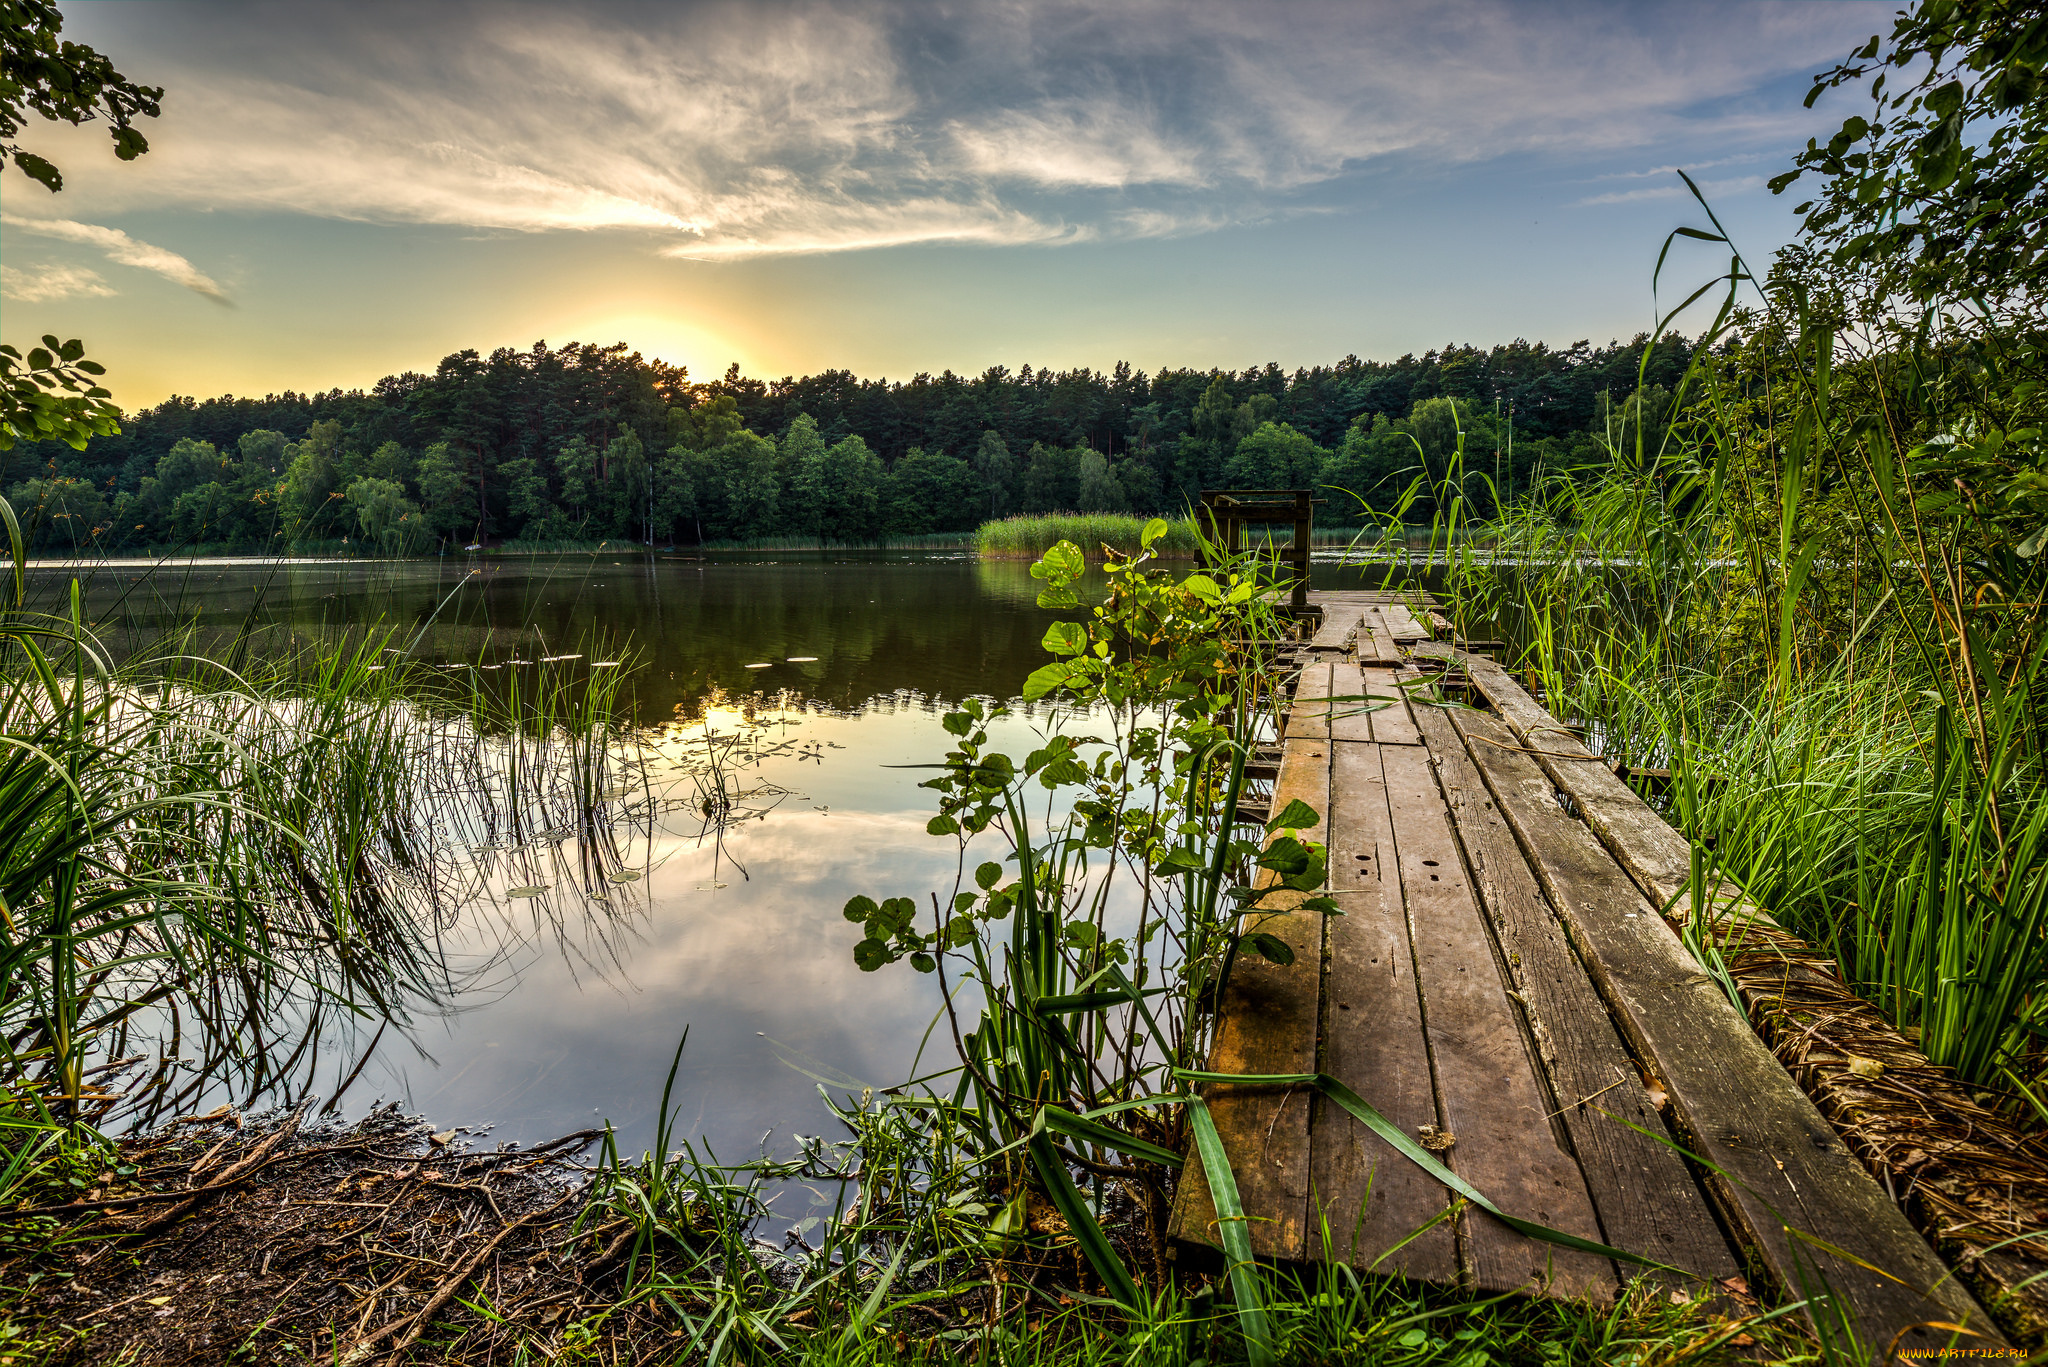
[1452,224,2048,1121]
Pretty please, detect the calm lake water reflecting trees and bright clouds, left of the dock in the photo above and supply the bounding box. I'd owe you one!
[37,555,1400,1158]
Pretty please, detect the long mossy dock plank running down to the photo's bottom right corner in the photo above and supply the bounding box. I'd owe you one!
[1425,656,2003,1349]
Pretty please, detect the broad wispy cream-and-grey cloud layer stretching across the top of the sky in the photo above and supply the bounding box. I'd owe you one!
[32,0,1884,258]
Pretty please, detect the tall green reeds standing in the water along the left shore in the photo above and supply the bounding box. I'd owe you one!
[0,498,647,1125]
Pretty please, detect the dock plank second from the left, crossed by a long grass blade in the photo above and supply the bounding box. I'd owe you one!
[1311,744,1458,1281]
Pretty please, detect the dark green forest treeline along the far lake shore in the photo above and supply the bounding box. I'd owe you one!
[0,338,1692,553]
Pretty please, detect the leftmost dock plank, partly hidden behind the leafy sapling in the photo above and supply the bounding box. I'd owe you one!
[1169,738,1331,1260]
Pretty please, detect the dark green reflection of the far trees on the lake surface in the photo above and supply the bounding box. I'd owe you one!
[56,557,1053,726]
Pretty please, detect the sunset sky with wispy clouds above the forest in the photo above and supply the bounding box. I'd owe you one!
[0,0,1894,410]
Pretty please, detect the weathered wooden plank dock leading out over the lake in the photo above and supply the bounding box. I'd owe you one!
[1174,592,2003,1361]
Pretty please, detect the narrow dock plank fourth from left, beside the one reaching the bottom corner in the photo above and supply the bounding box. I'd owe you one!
[1415,707,1741,1293]
